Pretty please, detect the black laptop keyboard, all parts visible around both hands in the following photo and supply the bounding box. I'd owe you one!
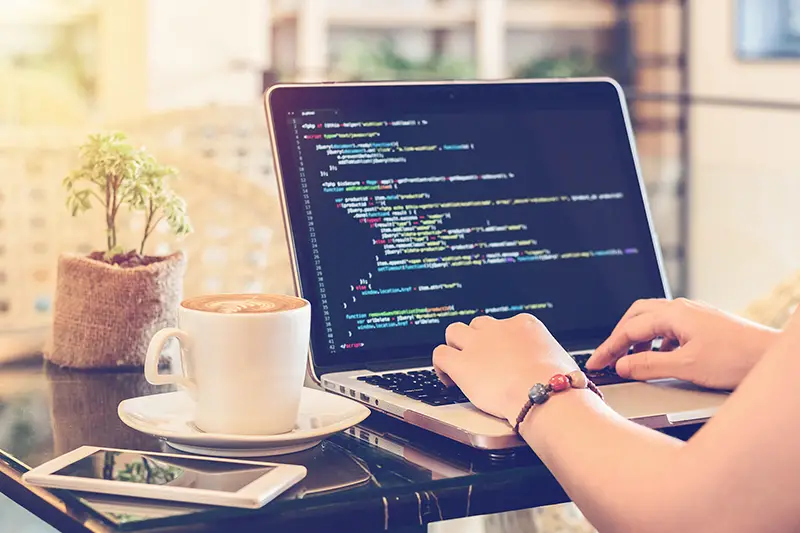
[357,354,630,406]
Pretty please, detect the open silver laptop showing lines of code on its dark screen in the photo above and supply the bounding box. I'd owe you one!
[265,78,727,449]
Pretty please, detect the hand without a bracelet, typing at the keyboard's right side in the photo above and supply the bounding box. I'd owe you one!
[586,298,779,390]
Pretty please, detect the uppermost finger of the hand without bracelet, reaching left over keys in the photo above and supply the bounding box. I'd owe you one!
[586,312,675,370]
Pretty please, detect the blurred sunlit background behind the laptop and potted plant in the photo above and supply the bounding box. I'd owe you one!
[0,0,800,531]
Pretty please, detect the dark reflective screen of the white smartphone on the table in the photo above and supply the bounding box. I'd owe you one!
[53,450,275,492]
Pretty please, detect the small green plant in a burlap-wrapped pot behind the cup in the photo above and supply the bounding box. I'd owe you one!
[45,133,191,368]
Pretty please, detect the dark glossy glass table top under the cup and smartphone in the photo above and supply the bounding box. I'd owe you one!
[0,361,600,531]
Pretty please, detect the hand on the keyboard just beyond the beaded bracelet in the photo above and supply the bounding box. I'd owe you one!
[433,314,578,425]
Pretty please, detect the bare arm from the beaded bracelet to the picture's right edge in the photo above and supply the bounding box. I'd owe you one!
[521,324,800,533]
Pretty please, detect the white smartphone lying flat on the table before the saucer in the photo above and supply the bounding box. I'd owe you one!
[22,446,306,509]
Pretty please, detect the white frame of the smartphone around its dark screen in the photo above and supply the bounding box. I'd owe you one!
[22,446,306,508]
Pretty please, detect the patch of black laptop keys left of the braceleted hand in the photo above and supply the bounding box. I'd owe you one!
[358,370,469,405]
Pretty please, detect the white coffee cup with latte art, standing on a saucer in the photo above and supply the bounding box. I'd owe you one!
[144,294,311,435]
